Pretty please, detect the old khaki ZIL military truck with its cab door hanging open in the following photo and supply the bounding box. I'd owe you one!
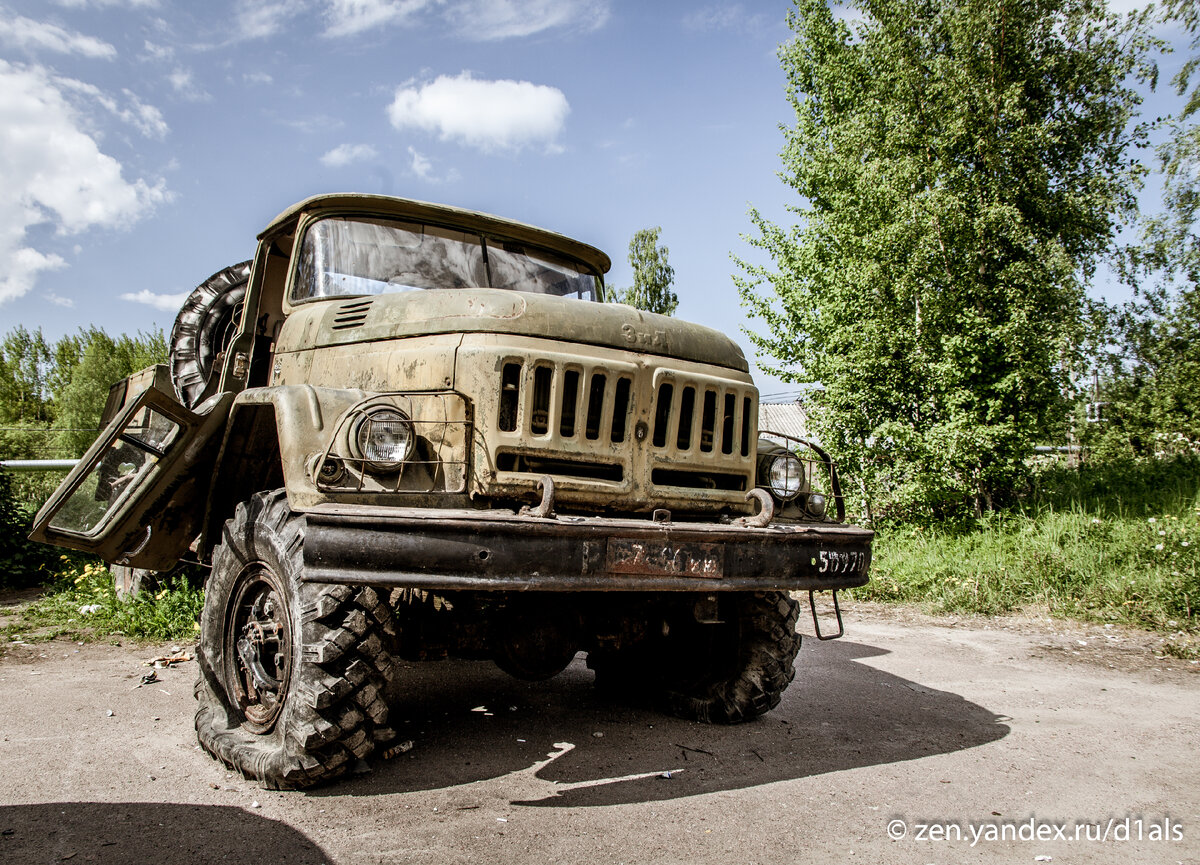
[32,194,872,788]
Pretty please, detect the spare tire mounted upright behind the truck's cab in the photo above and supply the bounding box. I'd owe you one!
[170,262,250,408]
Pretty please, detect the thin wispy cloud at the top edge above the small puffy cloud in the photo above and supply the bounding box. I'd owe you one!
[445,0,608,42]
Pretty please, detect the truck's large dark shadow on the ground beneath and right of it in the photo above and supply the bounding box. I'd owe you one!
[313,639,1009,806]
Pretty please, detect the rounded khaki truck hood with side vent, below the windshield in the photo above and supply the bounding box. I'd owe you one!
[276,288,750,372]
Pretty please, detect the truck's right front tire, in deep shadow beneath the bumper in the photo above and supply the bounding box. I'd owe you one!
[588,591,800,723]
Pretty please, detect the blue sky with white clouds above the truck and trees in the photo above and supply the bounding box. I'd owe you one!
[0,0,1186,395]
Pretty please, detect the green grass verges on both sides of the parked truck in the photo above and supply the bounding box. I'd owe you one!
[0,456,1200,643]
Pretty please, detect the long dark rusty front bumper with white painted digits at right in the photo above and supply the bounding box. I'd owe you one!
[297,505,875,591]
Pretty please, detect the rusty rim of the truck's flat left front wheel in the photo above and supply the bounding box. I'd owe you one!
[223,563,293,733]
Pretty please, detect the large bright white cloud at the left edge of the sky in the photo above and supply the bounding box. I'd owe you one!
[0,60,169,302]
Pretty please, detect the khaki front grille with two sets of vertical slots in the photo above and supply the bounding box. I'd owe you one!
[492,356,757,496]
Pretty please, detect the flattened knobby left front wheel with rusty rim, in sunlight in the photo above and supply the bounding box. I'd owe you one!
[196,489,396,789]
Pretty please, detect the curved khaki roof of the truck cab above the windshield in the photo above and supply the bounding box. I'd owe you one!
[258,192,612,274]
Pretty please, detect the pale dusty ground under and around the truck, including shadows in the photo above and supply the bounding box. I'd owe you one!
[0,607,1200,865]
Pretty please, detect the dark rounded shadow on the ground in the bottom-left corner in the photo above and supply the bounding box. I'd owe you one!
[0,801,332,865]
